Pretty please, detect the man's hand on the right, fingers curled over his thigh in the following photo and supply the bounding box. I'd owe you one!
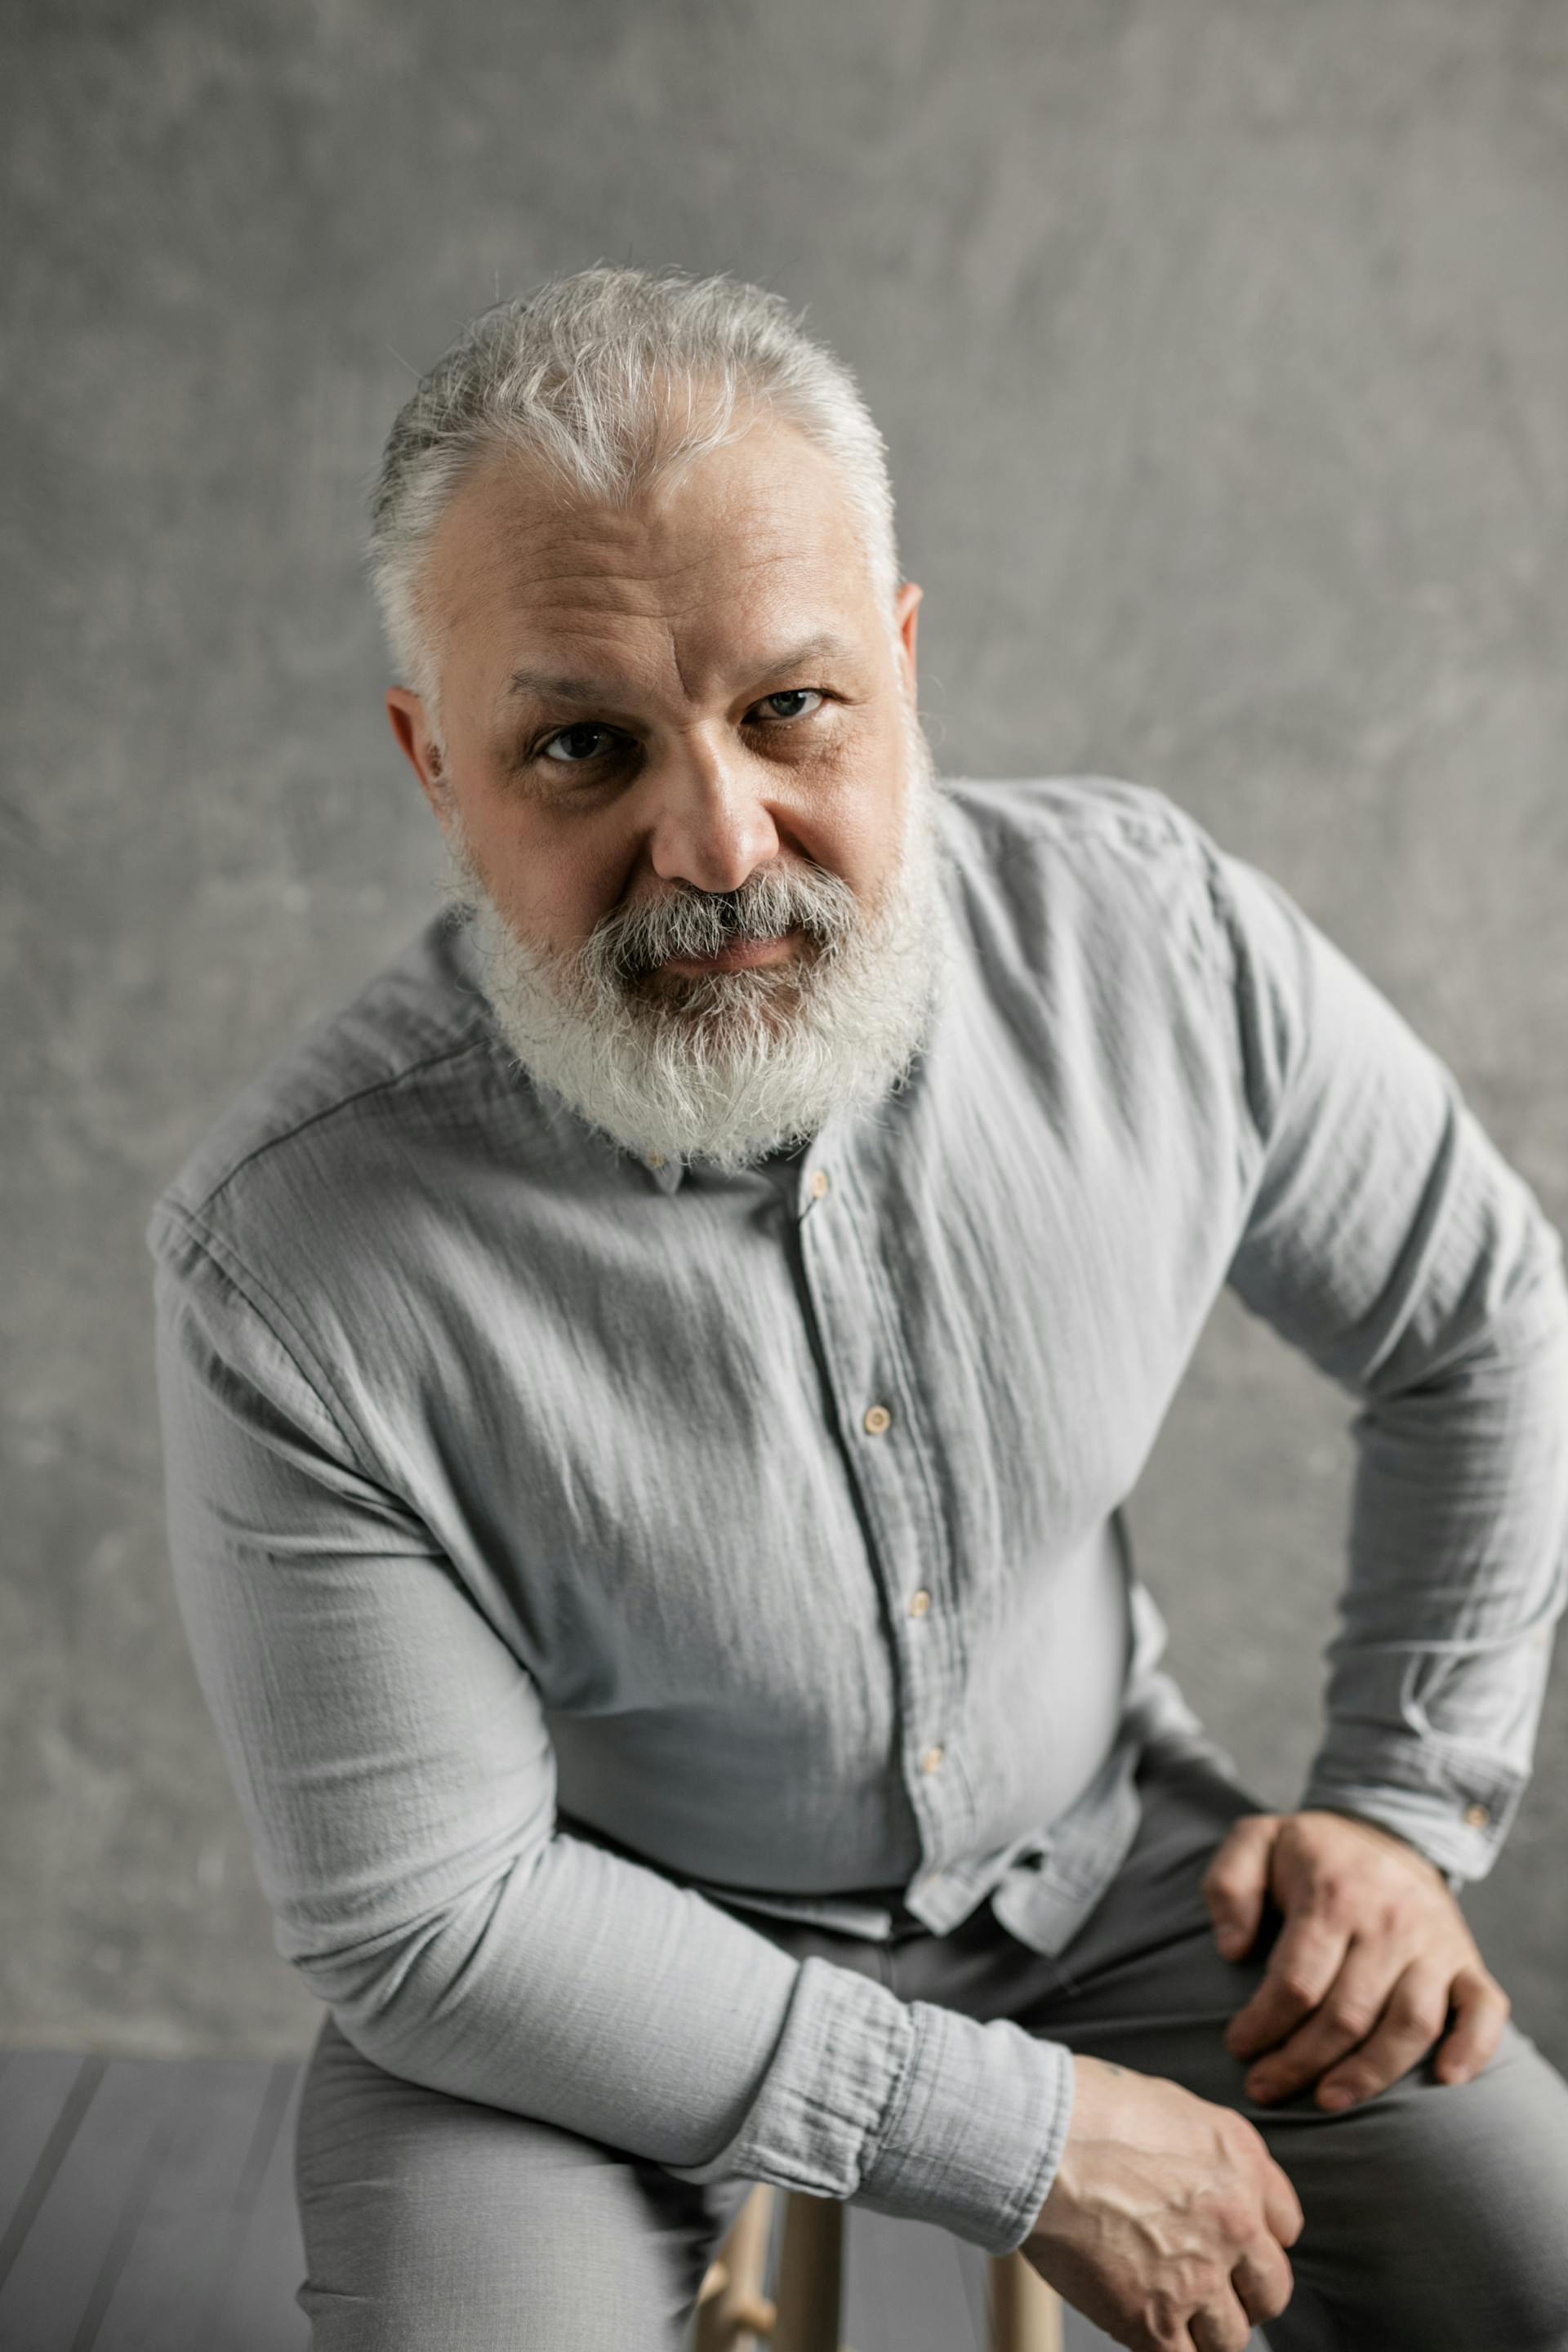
[1204,1811,1514,2107]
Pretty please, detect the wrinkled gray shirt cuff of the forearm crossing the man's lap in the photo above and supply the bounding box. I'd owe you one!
[666,1957,1075,2253]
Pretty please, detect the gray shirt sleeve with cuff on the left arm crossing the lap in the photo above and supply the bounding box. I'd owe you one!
[148,1211,1072,2253]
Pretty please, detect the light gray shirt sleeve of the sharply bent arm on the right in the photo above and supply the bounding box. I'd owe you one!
[1204,842,1568,1884]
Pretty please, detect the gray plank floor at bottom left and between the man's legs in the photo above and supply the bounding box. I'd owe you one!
[0,2051,1184,2352]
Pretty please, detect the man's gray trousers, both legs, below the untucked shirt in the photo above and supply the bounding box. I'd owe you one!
[296,1759,1568,2352]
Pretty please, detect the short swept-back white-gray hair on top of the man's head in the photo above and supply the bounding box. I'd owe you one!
[367,264,898,727]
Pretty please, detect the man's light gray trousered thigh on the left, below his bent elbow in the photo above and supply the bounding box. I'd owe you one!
[294,2013,750,2352]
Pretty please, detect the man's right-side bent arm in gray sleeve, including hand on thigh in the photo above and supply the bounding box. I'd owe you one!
[1189,853,1568,2105]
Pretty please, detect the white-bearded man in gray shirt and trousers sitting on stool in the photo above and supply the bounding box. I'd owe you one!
[148,268,1568,2352]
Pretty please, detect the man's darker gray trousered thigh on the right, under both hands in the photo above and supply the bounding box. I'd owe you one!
[898,1762,1568,2352]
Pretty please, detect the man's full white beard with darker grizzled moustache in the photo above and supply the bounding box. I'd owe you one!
[442,710,952,1171]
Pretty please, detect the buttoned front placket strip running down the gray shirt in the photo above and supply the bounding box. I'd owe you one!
[797,1138,976,1933]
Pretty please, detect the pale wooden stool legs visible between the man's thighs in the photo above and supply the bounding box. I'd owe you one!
[693,2183,1062,2352]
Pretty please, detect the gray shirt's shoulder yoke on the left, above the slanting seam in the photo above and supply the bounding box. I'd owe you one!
[145,911,493,1254]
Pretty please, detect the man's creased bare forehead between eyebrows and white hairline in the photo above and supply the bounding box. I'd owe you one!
[423,419,875,673]
